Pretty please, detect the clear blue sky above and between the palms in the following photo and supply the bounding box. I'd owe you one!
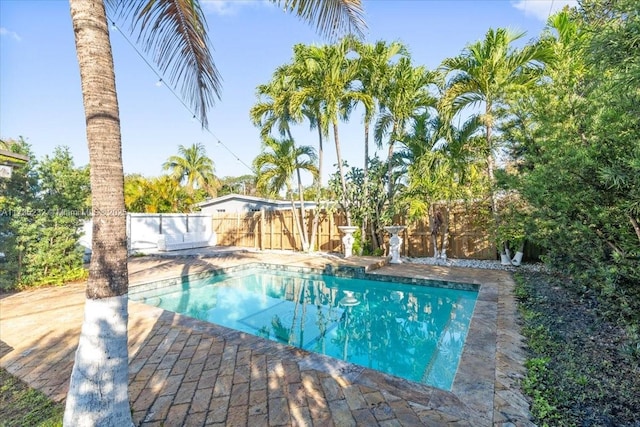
[0,0,576,184]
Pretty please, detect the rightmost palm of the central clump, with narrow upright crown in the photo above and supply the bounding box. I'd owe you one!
[375,58,436,204]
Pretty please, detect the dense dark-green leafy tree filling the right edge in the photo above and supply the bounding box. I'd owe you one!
[507,1,640,321]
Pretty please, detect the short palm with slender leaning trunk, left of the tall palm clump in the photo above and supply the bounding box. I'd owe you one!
[253,137,318,251]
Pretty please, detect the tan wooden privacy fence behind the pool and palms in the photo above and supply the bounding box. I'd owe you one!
[212,206,496,259]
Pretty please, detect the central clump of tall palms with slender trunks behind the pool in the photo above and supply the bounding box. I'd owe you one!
[251,37,435,248]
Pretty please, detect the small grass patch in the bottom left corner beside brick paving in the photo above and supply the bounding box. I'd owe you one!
[0,369,64,427]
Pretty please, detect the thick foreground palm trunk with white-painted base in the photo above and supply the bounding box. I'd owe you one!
[63,0,133,426]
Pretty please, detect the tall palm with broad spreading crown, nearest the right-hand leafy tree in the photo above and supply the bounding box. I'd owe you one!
[440,28,547,213]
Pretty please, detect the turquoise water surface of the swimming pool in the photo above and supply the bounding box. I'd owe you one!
[130,266,478,390]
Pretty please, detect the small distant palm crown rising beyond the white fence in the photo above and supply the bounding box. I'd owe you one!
[162,142,217,197]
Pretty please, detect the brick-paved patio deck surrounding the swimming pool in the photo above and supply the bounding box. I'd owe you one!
[0,251,533,427]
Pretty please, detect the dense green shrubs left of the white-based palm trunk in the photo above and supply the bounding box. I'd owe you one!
[0,139,91,290]
